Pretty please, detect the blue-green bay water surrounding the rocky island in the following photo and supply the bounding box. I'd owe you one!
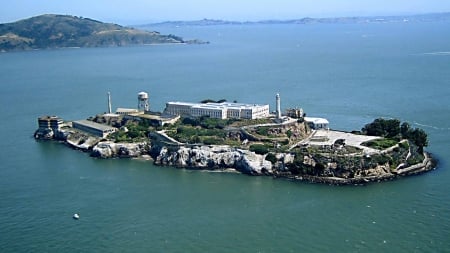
[0,22,450,252]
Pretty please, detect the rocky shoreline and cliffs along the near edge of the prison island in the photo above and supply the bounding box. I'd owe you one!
[35,126,436,185]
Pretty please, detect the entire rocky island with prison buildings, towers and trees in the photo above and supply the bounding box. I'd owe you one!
[34,92,437,185]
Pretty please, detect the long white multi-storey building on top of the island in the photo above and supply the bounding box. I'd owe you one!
[164,102,269,119]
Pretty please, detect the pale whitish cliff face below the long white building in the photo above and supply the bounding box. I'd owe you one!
[151,146,272,175]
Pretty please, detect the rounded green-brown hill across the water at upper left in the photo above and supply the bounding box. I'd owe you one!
[0,14,192,52]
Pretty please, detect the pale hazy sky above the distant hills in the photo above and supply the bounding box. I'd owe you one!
[0,0,450,24]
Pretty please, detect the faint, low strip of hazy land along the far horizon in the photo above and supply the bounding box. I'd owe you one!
[143,13,450,27]
